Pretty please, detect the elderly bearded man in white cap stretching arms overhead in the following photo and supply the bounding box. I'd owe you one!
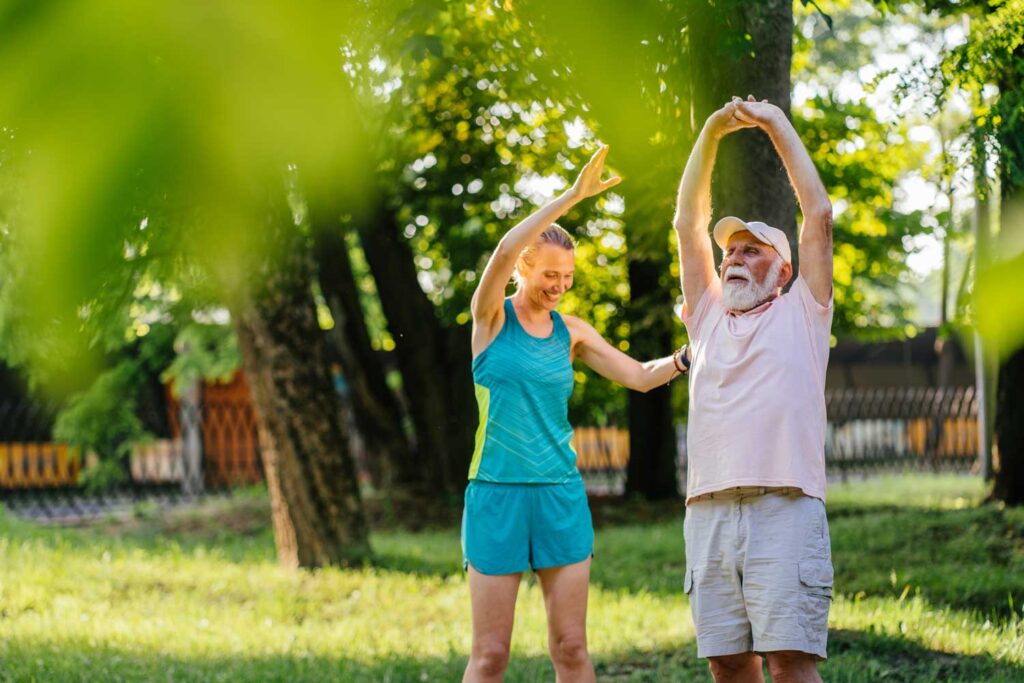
[675,97,833,682]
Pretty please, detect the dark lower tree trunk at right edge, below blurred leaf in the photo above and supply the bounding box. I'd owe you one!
[992,348,1024,505]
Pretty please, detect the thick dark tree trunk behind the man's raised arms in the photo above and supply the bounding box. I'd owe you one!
[688,0,798,264]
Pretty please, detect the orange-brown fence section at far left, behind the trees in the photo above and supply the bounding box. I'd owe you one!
[0,391,263,521]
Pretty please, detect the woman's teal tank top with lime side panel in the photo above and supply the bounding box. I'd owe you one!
[469,299,580,483]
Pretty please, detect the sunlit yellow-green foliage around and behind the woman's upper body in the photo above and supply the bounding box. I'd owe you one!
[356,0,629,424]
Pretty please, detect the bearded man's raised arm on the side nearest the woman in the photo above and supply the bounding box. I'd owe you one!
[673,102,756,314]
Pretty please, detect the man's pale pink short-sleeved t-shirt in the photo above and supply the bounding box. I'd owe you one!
[683,278,833,502]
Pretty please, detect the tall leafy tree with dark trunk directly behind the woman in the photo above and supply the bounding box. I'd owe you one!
[348,0,598,494]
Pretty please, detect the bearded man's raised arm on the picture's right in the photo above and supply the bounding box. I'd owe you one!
[733,97,833,306]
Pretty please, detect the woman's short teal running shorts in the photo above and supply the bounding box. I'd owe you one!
[462,479,594,575]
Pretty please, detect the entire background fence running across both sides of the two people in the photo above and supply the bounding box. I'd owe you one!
[0,387,978,520]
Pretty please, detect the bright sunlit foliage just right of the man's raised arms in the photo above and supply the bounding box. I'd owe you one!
[793,2,948,340]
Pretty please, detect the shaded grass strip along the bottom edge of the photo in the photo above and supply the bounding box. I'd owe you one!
[0,631,1024,683]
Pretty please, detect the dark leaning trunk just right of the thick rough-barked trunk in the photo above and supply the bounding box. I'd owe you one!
[309,204,422,490]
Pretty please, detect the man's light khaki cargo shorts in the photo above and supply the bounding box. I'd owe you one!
[683,488,833,659]
